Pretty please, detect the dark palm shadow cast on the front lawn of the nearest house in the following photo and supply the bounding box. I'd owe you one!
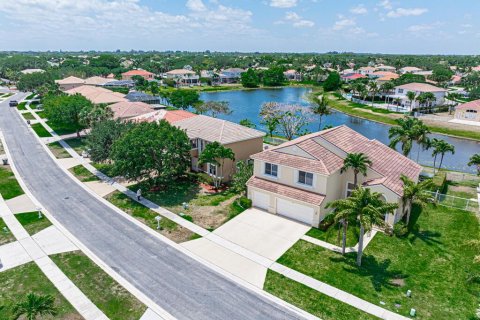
[330,253,408,292]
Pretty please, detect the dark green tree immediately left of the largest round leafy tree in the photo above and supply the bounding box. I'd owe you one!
[86,120,133,162]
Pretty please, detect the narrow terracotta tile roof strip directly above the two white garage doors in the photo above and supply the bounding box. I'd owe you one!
[247,177,325,206]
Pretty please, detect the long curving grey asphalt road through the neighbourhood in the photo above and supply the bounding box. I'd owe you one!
[0,94,301,320]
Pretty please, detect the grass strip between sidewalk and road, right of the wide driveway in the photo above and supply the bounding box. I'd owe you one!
[263,270,377,320]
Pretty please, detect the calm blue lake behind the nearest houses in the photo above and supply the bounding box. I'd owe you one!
[200,87,480,172]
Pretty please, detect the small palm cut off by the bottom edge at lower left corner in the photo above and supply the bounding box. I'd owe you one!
[13,292,57,320]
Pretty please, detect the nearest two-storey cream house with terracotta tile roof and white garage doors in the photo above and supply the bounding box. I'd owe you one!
[247,126,422,227]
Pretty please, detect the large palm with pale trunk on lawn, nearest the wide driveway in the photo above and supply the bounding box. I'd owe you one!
[328,188,398,266]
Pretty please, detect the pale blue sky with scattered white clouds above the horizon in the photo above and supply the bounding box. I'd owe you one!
[0,0,480,54]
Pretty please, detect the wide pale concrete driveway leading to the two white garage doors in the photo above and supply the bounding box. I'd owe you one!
[182,209,310,288]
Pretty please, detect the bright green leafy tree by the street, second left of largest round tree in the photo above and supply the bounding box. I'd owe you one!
[43,93,93,137]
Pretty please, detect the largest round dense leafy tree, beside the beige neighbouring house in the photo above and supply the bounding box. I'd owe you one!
[110,120,191,187]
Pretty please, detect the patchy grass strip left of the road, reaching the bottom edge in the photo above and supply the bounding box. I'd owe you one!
[51,251,147,320]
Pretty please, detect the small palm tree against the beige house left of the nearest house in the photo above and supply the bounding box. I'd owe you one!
[198,141,235,189]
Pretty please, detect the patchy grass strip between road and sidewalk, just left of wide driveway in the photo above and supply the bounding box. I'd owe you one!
[105,191,195,243]
